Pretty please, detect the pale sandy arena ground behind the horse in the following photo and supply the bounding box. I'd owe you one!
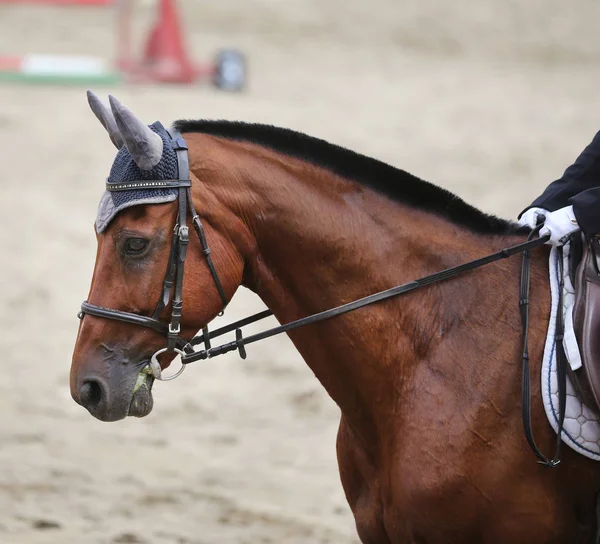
[0,0,600,544]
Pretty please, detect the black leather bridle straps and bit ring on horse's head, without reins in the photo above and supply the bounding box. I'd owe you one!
[78,129,227,380]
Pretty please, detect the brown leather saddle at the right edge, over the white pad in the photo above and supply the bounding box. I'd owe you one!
[567,233,600,414]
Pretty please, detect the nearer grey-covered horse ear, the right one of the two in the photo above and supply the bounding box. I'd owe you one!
[108,95,163,170]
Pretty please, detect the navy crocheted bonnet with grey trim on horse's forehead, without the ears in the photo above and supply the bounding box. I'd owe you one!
[96,121,179,233]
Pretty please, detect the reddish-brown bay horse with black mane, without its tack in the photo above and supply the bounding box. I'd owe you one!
[71,95,600,544]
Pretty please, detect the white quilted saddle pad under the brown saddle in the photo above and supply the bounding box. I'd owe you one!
[542,244,600,461]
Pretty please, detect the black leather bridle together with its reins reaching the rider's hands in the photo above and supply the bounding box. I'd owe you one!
[78,133,566,467]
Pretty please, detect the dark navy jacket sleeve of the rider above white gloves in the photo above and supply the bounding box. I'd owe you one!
[521,132,600,217]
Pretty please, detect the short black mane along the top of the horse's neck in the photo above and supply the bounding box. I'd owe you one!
[173,119,519,235]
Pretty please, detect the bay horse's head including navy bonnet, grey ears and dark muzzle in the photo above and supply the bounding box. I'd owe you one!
[71,92,243,421]
